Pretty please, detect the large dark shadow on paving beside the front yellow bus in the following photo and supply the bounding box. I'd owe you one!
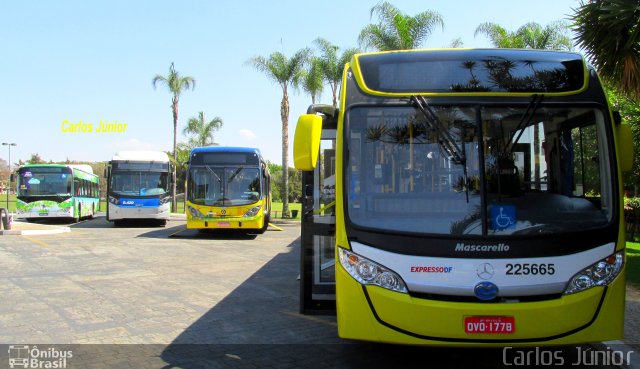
[161,239,592,369]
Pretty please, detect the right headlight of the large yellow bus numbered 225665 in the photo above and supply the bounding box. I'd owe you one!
[564,251,624,295]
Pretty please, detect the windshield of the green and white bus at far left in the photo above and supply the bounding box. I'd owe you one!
[18,167,73,196]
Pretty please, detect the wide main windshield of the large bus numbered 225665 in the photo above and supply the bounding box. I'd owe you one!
[345,104,613,236]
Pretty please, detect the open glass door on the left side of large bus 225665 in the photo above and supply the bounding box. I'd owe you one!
[300,126,336,314]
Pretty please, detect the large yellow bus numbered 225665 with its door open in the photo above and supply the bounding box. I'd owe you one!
[294,49,632,346]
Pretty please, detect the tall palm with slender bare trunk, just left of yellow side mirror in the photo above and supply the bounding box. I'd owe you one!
[248,48,310,218]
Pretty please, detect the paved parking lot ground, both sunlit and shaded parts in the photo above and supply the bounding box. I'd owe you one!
[0,214,640,369]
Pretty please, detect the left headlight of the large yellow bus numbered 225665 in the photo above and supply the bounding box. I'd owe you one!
[338,247,407,293]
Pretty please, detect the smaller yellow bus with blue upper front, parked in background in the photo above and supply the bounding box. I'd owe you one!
[186,147,271,233]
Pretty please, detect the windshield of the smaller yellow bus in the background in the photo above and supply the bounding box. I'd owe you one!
[187,165,261,206]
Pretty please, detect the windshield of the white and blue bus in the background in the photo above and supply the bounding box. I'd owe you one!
[110,170,169,196]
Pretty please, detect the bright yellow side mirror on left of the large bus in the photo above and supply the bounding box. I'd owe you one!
[293,114,322,171]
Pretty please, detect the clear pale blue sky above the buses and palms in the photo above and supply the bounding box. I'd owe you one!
[0,0,579,163]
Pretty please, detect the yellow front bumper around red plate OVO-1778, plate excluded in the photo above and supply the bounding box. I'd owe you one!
[336,267,625,346]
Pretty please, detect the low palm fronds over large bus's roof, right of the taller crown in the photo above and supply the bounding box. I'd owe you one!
[475,21,573,50]
